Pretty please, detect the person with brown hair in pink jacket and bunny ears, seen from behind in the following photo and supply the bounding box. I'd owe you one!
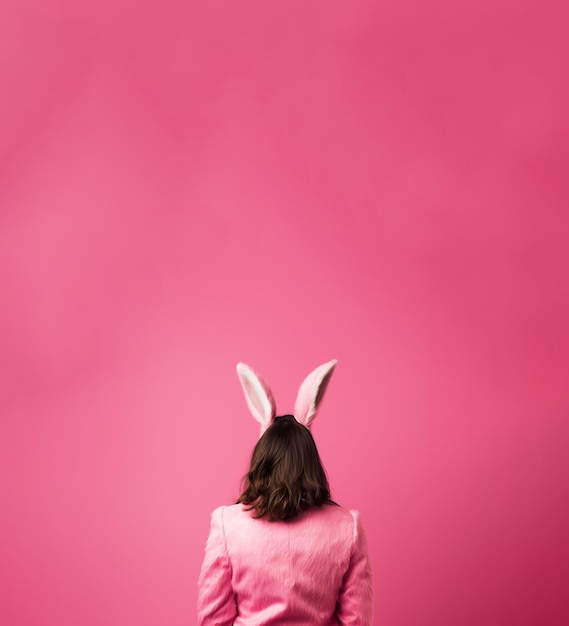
[198,361,373,626]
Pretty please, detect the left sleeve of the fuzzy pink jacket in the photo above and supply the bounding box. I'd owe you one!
[198,507,237,626]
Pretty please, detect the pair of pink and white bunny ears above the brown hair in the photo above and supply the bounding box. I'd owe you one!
[237,360,338,435]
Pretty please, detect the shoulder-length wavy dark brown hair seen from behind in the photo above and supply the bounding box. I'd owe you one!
[237,415,335,520]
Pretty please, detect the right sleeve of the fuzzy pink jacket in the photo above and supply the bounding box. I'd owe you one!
[336,511,373,626]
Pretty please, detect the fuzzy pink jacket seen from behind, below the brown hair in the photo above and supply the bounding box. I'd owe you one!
[198,504,373,626]
